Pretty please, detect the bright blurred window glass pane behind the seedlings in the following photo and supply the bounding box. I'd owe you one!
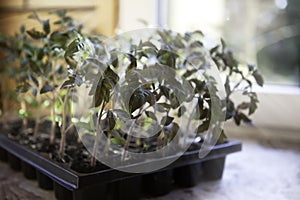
[168,0,300,86]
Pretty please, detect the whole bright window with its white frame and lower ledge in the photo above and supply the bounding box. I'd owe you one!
[119,0,300,132]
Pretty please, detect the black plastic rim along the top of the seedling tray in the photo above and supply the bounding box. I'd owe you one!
[0,134,241,199]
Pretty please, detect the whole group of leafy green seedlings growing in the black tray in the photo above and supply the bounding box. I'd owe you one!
[1,11,263,166]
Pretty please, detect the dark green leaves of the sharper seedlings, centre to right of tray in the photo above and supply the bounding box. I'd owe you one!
[65,27,263,152]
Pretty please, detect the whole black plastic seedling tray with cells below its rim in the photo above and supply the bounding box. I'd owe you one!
[0,134,241,199]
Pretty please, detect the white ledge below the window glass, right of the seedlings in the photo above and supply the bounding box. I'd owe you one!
[229,85,300,133]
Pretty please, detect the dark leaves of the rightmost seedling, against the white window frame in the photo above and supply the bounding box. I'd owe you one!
[210,39,264,125]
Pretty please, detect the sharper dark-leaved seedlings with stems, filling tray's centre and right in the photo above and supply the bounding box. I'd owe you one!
[66,30,263,164]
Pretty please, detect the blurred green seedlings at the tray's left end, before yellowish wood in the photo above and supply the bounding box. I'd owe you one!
[0,11,81,159]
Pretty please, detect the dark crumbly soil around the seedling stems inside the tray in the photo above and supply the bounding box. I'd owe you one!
[0,120,209,173]
